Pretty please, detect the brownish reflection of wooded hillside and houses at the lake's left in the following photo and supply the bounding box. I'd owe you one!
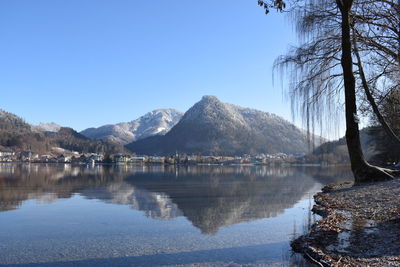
[0,164,128,211]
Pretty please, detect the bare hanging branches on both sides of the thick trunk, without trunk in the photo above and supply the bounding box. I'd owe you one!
[268,0,400,132]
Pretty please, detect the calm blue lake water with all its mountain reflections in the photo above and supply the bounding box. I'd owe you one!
[0,164,351,266]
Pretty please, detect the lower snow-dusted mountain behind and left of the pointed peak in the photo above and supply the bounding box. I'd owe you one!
[81,109,183,144]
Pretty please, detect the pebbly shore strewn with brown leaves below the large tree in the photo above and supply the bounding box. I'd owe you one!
[292,179,400,266]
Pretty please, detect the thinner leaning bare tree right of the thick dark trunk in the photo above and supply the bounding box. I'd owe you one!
[352,0,400,148]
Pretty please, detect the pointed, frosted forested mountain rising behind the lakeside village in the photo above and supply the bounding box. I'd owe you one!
[126,96,320,156]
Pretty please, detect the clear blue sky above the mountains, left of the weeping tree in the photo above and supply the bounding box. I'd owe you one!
[0,0,295,130]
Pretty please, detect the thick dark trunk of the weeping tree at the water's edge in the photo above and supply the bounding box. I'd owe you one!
[336,0,393,184]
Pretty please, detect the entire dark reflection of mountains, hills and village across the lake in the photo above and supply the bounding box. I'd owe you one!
[0,165,345,236]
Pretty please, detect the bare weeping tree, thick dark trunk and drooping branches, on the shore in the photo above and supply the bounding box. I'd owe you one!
[259,0,398,183]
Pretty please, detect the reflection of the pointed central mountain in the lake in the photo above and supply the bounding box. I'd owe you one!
[122,168,334,236]
